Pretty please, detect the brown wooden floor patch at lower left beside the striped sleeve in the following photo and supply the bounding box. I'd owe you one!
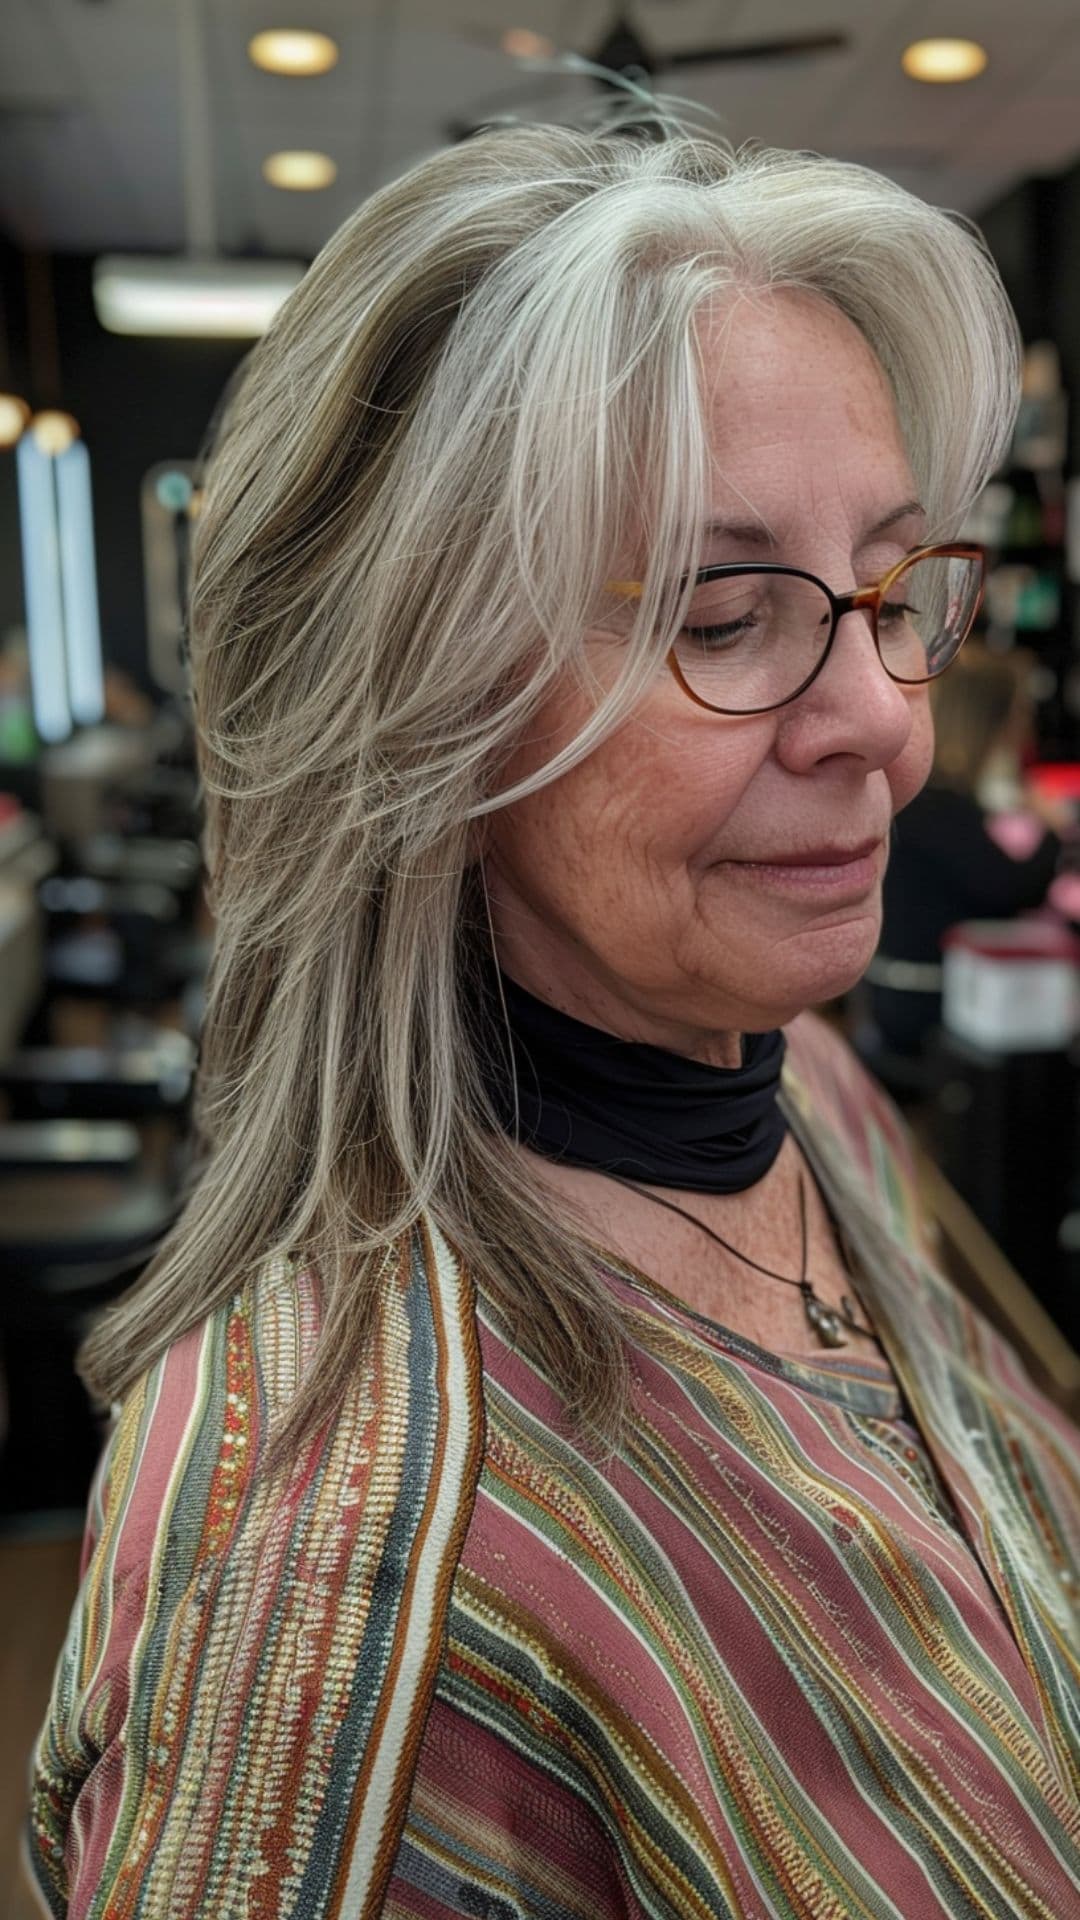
[0,1519,81,1920]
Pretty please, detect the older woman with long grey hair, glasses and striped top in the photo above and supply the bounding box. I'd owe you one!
[27,127,1080,1920]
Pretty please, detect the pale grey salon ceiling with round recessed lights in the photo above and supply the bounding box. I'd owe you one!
[0,0,1080,257]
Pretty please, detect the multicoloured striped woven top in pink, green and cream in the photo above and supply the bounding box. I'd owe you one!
[23,1016,1080,1920]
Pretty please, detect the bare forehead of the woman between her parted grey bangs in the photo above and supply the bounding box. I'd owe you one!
[698,288,913,533]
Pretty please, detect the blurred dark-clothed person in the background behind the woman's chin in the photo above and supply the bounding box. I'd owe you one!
[865,639,1070,1058]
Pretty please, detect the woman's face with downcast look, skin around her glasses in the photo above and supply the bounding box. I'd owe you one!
[484,292,932,1064]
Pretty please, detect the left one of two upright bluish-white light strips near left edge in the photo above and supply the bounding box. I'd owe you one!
[15,434,71,747]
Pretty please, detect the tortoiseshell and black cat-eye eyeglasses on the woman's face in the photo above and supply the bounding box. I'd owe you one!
[598,545,986,714]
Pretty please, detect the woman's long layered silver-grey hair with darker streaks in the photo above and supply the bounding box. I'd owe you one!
[81,116,1019,1471]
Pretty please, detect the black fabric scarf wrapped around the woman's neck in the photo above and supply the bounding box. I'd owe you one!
[479,973,788,1194]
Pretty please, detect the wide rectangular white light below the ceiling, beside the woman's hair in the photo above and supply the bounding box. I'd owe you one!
[94,253,307,340]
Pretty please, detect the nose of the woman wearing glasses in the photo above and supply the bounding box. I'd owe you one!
[778,607,924,772]
